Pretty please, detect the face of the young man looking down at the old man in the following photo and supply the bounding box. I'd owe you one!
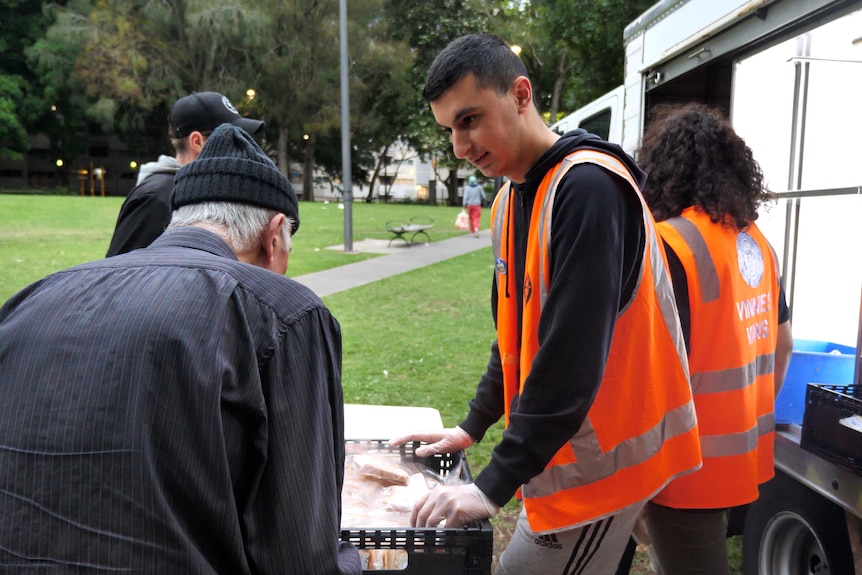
[431,74,529,181]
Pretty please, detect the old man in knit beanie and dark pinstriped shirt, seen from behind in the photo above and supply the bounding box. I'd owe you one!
[0,124,361,575]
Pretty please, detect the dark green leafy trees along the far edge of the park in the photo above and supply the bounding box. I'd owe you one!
[5,0,649,187]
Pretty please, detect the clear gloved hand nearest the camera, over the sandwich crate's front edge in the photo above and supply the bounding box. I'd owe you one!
[410,483,500,527]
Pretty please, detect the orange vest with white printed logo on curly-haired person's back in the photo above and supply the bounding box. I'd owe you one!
[655,208,779,509]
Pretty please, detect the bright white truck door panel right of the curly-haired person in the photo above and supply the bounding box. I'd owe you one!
[731,5,862,347]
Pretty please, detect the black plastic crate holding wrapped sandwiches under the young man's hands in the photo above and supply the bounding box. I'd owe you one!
[341,440,494,575]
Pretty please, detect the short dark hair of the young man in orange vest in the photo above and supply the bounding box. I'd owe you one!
[422,34,527,102]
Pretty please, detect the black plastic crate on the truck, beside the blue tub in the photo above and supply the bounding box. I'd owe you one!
[800,383,862,476]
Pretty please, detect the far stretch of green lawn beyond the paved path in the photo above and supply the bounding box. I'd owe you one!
[0,194,480,302]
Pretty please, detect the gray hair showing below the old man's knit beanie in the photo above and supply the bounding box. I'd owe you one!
[168,202,294,252]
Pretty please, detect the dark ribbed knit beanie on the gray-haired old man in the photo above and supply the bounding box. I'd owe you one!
[171,124,299,234]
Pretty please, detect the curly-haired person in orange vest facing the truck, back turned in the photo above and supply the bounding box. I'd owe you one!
[638,104,793,575]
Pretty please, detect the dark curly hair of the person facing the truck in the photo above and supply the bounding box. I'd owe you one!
[637,103,772,229]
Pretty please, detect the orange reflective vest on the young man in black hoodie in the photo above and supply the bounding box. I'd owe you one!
[491,150,700,533]
